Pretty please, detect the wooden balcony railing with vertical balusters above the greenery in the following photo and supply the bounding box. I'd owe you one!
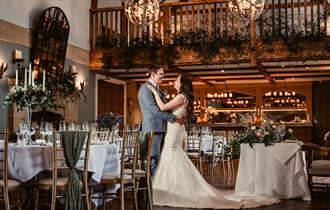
[90,0,328,50]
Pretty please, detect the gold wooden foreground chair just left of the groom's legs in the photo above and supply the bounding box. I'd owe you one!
[93,131,140,210]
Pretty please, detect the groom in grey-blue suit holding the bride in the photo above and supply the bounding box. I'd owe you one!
[138,64,185,175]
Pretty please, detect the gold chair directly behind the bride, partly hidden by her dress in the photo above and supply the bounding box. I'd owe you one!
[186,131,203,175]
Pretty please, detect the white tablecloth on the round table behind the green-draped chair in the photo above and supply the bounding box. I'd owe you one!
[8,144,120,182]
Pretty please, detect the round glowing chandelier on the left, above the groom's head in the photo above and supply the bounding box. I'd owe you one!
[125,0,159,26]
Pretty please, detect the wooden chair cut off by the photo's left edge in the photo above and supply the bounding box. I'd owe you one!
[0,129,22,210]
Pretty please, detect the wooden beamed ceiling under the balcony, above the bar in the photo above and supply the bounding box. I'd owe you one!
[101,60,330,85]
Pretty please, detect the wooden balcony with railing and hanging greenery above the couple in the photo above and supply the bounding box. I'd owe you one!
[90,0,330,83]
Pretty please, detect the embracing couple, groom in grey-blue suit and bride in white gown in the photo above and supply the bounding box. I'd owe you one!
[138,65,278,209]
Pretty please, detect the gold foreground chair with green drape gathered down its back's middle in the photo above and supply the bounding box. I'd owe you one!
[35,130,91,210]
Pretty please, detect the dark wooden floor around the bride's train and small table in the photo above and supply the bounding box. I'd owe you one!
[111,171,330,210]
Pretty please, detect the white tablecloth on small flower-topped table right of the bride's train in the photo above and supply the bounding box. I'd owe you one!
[235,143,310,200]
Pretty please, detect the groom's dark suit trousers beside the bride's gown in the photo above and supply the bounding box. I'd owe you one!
[150,132,165,176]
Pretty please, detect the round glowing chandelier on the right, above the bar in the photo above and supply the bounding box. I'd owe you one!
[229,0,265,22]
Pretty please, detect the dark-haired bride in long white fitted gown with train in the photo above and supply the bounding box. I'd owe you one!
[148,75,279,209]
